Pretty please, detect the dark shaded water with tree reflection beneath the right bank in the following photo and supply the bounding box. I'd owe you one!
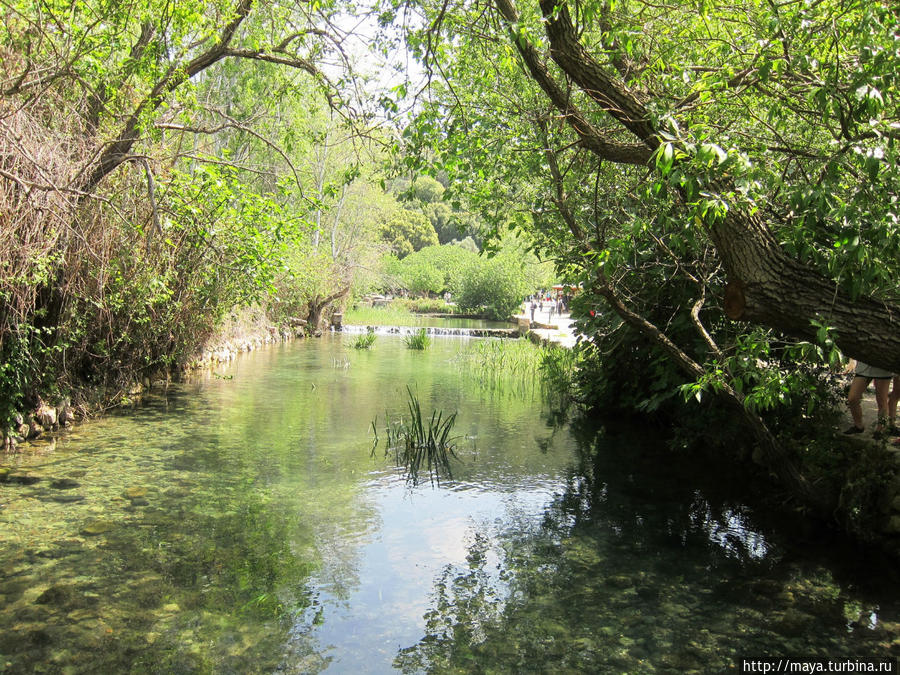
[394,432,900,673]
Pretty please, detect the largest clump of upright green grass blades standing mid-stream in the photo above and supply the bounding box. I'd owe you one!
[372,387,459,485]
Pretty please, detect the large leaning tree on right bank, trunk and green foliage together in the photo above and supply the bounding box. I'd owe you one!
[390,0,900,508]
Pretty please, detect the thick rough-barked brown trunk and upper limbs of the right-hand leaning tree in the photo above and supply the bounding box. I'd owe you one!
[532,0,900,372]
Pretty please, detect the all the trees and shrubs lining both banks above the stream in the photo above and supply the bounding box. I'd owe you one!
[0,0,900,540]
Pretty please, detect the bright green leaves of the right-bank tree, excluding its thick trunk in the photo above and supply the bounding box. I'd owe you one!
[390,2,900,460]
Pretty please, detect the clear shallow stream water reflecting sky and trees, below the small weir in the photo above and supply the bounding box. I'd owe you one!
[0,335,900,673]
